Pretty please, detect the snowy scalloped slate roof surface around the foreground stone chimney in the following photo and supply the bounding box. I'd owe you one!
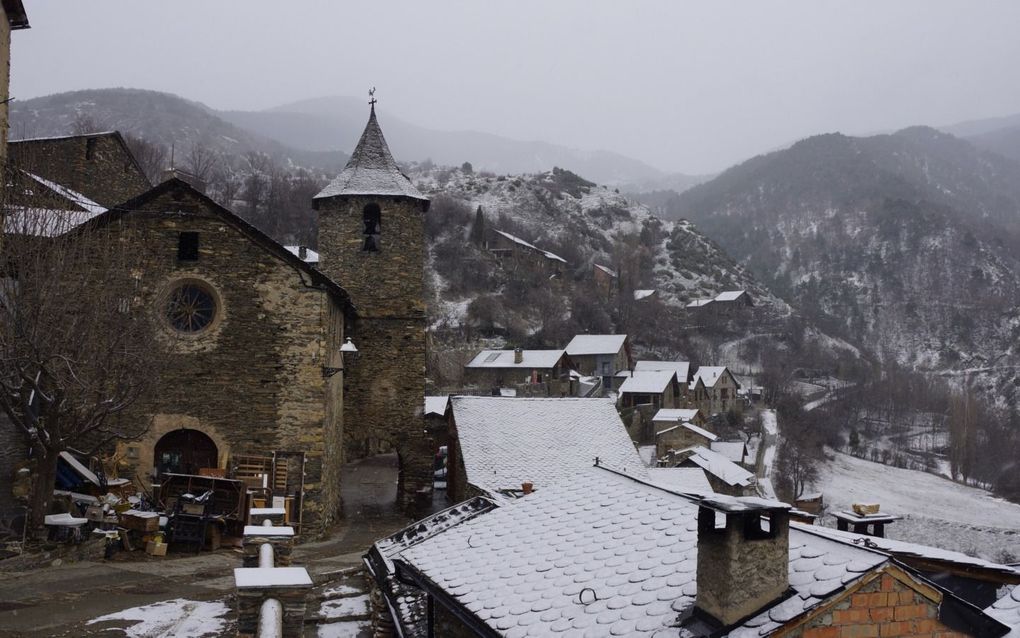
[400,468,887,636]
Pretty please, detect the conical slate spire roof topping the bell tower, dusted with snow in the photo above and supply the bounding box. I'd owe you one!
[315,105,428,201]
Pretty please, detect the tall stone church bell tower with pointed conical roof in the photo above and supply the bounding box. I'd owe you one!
[313,98,435,503]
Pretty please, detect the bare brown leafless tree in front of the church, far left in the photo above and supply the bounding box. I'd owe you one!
[0,200,160,532]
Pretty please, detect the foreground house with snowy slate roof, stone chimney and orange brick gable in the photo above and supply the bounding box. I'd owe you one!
[365,463,1020,638]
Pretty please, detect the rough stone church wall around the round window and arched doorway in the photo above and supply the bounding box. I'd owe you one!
[107,186,344,531]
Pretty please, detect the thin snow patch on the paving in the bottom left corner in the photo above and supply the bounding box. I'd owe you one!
[89,598,231,638]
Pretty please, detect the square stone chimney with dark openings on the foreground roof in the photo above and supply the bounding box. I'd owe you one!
[696,494,789,627]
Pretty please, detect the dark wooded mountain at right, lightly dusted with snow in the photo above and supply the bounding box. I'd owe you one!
[668,127,1020,405]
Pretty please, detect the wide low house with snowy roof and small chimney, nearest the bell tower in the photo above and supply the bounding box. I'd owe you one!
[464,348,573,396]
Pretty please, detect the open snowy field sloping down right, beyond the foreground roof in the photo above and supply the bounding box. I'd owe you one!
[815,451,1020,561]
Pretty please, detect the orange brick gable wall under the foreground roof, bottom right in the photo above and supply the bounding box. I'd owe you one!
[787,573,967,638]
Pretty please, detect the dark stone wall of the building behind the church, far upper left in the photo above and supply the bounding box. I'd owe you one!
[8,133,152,207]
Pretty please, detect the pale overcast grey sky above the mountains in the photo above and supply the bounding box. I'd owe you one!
[11,0,1020,174]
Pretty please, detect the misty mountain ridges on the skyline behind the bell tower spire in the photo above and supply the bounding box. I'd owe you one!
[10,89,703,190]
